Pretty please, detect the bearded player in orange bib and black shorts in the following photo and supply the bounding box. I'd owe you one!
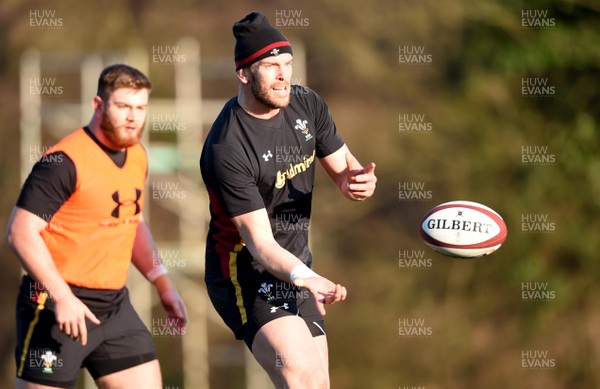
[7,64,188,388]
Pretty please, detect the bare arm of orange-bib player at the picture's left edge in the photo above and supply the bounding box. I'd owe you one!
[6,207,100,345]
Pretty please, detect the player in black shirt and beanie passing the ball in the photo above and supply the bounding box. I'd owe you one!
[200,12,377,389]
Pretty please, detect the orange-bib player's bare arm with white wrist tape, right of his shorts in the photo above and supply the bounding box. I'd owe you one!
[131,217,188,329]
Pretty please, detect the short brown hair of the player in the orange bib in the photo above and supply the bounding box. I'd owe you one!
[96,64,152,101]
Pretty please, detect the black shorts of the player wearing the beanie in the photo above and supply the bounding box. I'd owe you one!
[206,272,325,351]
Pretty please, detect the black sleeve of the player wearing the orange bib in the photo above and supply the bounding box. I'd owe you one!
[17,151,77,221]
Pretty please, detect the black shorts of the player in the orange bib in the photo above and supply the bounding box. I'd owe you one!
[15,276,156,388]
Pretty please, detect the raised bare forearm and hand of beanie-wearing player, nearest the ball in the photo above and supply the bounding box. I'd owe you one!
[320,145,377,201]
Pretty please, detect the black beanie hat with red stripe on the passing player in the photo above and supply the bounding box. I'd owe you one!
[233,12,292,71]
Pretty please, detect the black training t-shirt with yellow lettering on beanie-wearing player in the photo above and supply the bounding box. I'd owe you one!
[200,85,344,281]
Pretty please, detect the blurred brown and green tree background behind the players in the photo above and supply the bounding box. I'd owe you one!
[0,0,600,388]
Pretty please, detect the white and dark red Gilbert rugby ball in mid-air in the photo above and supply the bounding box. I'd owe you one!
[420,201,507,258]
